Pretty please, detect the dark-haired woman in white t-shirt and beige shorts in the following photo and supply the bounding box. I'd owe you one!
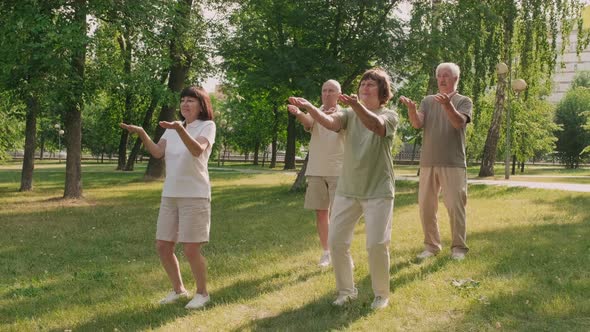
[121,87,215,309]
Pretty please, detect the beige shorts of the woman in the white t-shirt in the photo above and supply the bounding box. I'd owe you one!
[156,197,211,243]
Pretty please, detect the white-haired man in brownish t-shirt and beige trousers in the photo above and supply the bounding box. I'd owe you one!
[400,62,473,260]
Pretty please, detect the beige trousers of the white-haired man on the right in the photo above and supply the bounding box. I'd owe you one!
[418,166,469,254]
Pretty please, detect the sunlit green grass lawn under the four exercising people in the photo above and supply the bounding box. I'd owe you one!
[0,164,590,331]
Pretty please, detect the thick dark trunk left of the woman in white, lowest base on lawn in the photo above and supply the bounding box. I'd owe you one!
[63,0,88,199]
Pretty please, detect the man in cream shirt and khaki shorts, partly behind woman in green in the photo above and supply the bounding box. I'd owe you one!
[288,80,344,267]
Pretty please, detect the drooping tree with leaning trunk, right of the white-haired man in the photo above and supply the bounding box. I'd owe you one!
[479,0,588,176]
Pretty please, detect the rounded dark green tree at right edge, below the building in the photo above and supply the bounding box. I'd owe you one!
[555,87,590,168]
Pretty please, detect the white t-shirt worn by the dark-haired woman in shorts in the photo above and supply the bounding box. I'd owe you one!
[161,120,215,198]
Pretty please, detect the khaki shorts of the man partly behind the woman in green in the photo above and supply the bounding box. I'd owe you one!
[303,176,338,210]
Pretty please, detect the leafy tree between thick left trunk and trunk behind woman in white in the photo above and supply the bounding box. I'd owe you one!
[92,0,171,170]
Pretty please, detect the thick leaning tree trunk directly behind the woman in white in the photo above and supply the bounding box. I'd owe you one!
[144,0,193,180]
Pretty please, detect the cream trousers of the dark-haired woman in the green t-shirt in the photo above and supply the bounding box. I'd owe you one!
[328,194,393,297]
